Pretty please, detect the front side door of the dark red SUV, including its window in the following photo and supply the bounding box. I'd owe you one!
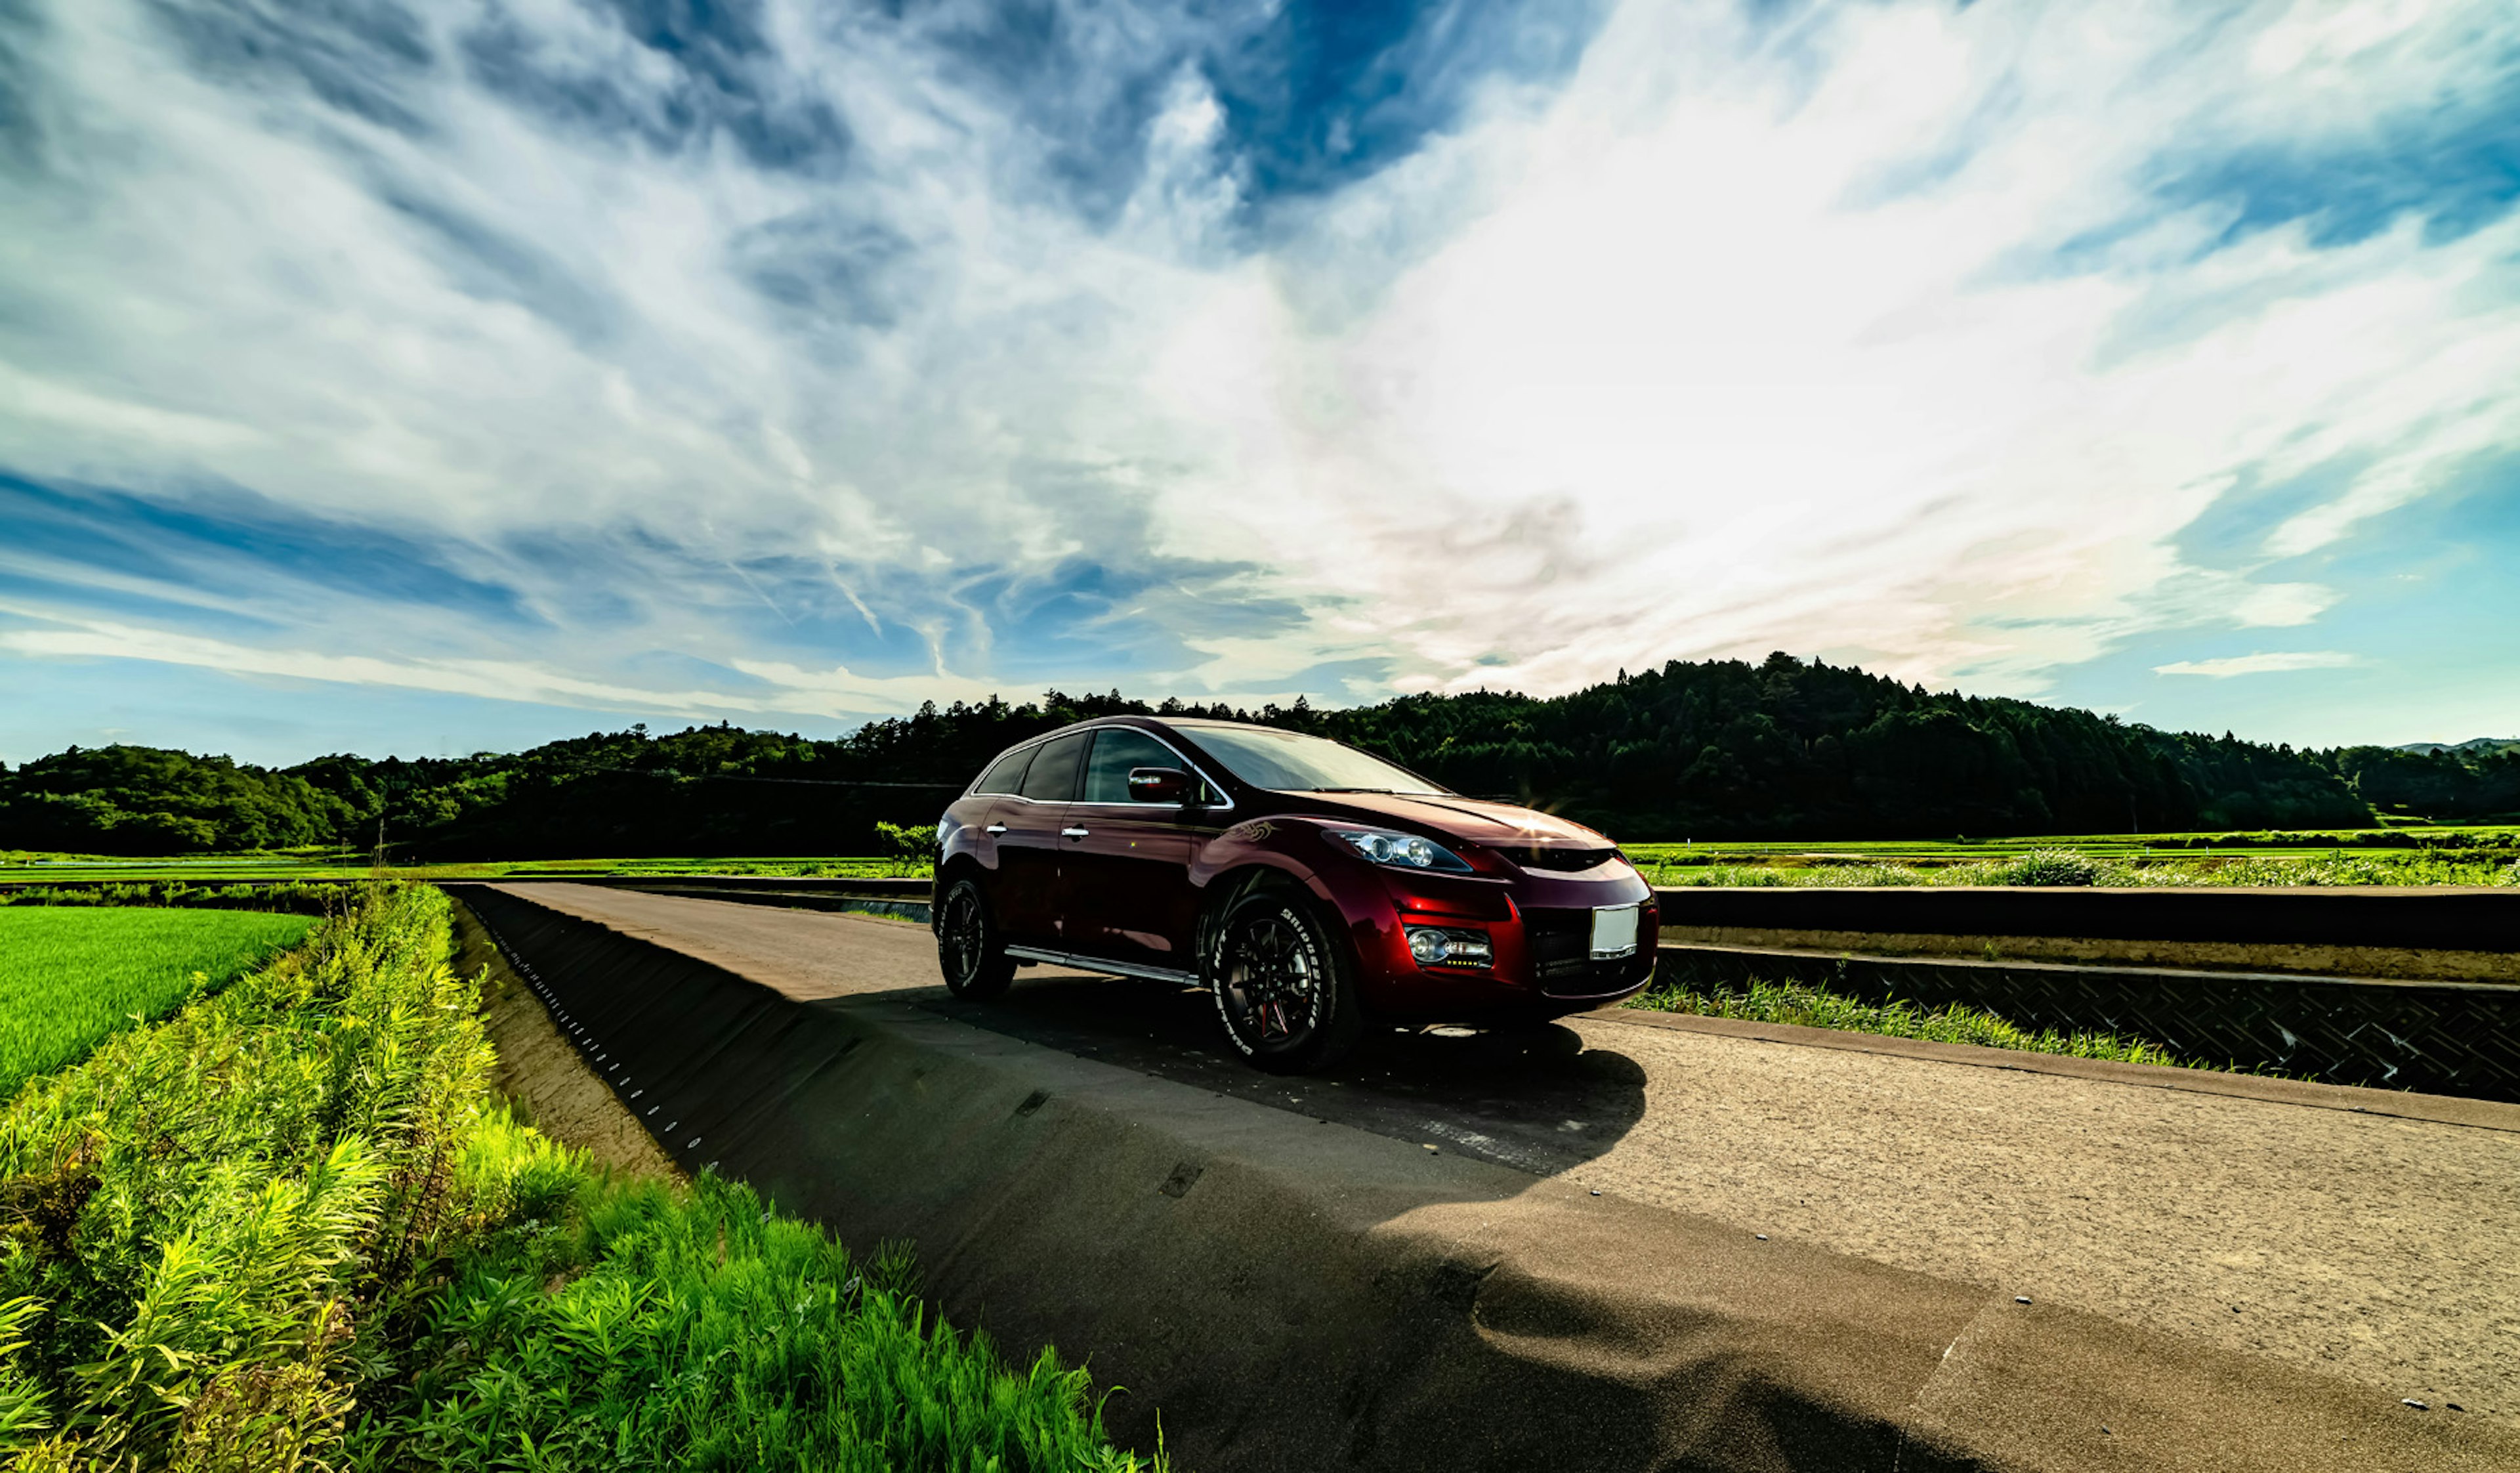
[1059,727,1200,971]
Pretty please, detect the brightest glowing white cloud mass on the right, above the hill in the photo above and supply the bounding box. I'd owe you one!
[1154,5,2520,691]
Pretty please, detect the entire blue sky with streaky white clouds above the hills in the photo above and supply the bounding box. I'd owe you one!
[0,0,2520,761]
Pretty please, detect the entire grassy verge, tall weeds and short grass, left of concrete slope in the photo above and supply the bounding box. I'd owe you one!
[0,886,1159,1473]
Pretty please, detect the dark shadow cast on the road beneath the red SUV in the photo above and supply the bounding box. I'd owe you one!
[917,973,1646,1176]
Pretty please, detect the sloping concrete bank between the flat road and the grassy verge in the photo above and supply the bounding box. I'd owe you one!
[453,886,2520,1473]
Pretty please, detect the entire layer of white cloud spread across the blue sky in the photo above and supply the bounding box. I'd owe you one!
[0,0,2520,741]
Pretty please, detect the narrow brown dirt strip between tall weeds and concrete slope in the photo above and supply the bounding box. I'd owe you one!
[453,901,683,1178]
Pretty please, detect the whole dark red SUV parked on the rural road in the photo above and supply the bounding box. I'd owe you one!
[935,716,1658,1072]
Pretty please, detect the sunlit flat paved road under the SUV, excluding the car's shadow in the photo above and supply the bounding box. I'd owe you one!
[491,886,2520,1425]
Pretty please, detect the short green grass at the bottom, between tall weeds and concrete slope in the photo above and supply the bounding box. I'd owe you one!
[350,1120,1142,1473]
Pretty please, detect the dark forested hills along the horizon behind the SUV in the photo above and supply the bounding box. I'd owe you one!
[0,653,2520,860]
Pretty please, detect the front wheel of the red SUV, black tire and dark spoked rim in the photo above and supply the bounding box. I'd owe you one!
[1207,888,1366,1075]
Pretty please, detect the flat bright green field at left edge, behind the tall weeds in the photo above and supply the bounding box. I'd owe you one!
[0,905,312,1099]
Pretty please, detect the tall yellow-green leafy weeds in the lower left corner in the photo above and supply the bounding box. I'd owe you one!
[0,888,489,1470]
